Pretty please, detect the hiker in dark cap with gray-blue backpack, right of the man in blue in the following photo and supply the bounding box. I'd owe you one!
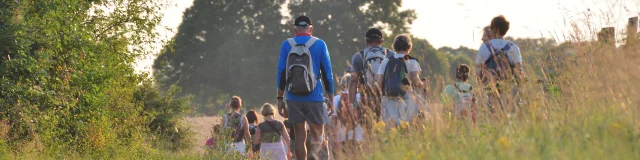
[347,28,395,128]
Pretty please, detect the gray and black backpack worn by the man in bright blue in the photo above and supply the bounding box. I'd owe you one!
[285,37,318,95]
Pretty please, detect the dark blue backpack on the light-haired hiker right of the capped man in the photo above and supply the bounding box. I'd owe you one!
[382,55,416,97]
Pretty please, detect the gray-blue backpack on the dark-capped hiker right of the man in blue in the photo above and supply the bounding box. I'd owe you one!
[360,47,389,87]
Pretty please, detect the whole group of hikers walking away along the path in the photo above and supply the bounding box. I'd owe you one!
[207,16,526,160]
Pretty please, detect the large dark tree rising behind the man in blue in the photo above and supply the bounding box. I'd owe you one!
[154,0,415,112]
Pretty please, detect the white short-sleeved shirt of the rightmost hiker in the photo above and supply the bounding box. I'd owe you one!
[475,39,522,64]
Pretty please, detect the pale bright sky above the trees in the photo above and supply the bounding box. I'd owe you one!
[136,0,640,71]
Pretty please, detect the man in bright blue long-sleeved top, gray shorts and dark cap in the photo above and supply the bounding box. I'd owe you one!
[276,16,334,160]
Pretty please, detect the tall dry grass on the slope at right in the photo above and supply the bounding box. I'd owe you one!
[349,26,640,159]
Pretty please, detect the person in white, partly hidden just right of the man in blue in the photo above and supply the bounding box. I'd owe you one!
[330,73,364,155]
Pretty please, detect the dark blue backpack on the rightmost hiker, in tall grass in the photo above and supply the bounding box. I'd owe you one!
[484,42,514,81]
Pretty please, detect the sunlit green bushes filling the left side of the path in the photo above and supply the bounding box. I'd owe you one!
[0,0,192,158]
